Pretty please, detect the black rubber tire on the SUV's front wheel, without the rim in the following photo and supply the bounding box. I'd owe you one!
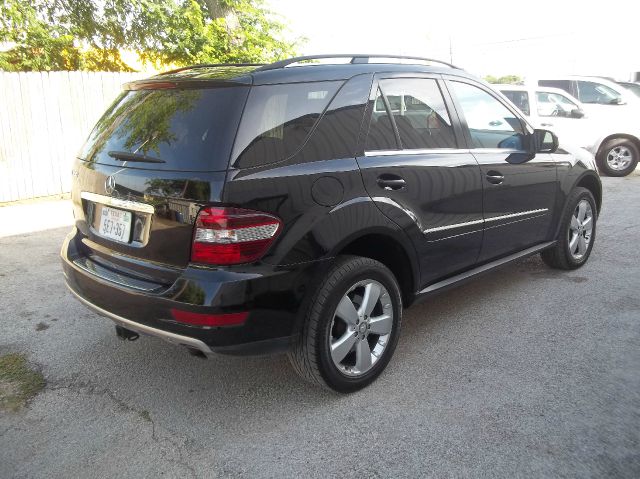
[540,187,598,270]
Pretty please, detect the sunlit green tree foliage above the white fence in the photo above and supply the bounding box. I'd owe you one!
[0,0,295,71]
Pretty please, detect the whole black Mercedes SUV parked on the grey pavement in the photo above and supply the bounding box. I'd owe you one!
[62,55,602,392]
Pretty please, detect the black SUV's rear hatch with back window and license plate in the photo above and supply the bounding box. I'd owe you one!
[73,69,250,289]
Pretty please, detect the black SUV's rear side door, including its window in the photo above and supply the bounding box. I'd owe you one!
[358,74,483,286]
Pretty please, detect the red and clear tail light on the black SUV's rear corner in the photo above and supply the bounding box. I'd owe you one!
[191,207,282,265]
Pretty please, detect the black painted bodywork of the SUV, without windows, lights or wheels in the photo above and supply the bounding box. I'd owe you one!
[62,60,601,353]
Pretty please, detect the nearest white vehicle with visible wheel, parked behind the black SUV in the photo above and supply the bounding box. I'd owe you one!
[493,85,640,176]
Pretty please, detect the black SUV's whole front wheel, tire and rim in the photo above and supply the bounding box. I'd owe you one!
[541,188,597,269]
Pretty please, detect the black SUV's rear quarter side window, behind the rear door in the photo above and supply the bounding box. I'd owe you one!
[233,82,343,168]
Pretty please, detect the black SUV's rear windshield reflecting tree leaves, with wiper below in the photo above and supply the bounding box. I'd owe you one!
[80,86,249,171]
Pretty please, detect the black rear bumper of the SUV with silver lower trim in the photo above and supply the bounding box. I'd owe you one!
[61,230,327,354]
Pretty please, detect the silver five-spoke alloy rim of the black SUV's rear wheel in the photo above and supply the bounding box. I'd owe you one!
[329,279,394,377]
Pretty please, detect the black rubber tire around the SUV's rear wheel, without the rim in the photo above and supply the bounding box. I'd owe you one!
[289,256,402,393]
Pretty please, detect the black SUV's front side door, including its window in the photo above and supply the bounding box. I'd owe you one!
[447,79,557,262]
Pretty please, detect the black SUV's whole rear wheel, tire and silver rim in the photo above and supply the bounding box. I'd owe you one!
[289,256,402,393]
